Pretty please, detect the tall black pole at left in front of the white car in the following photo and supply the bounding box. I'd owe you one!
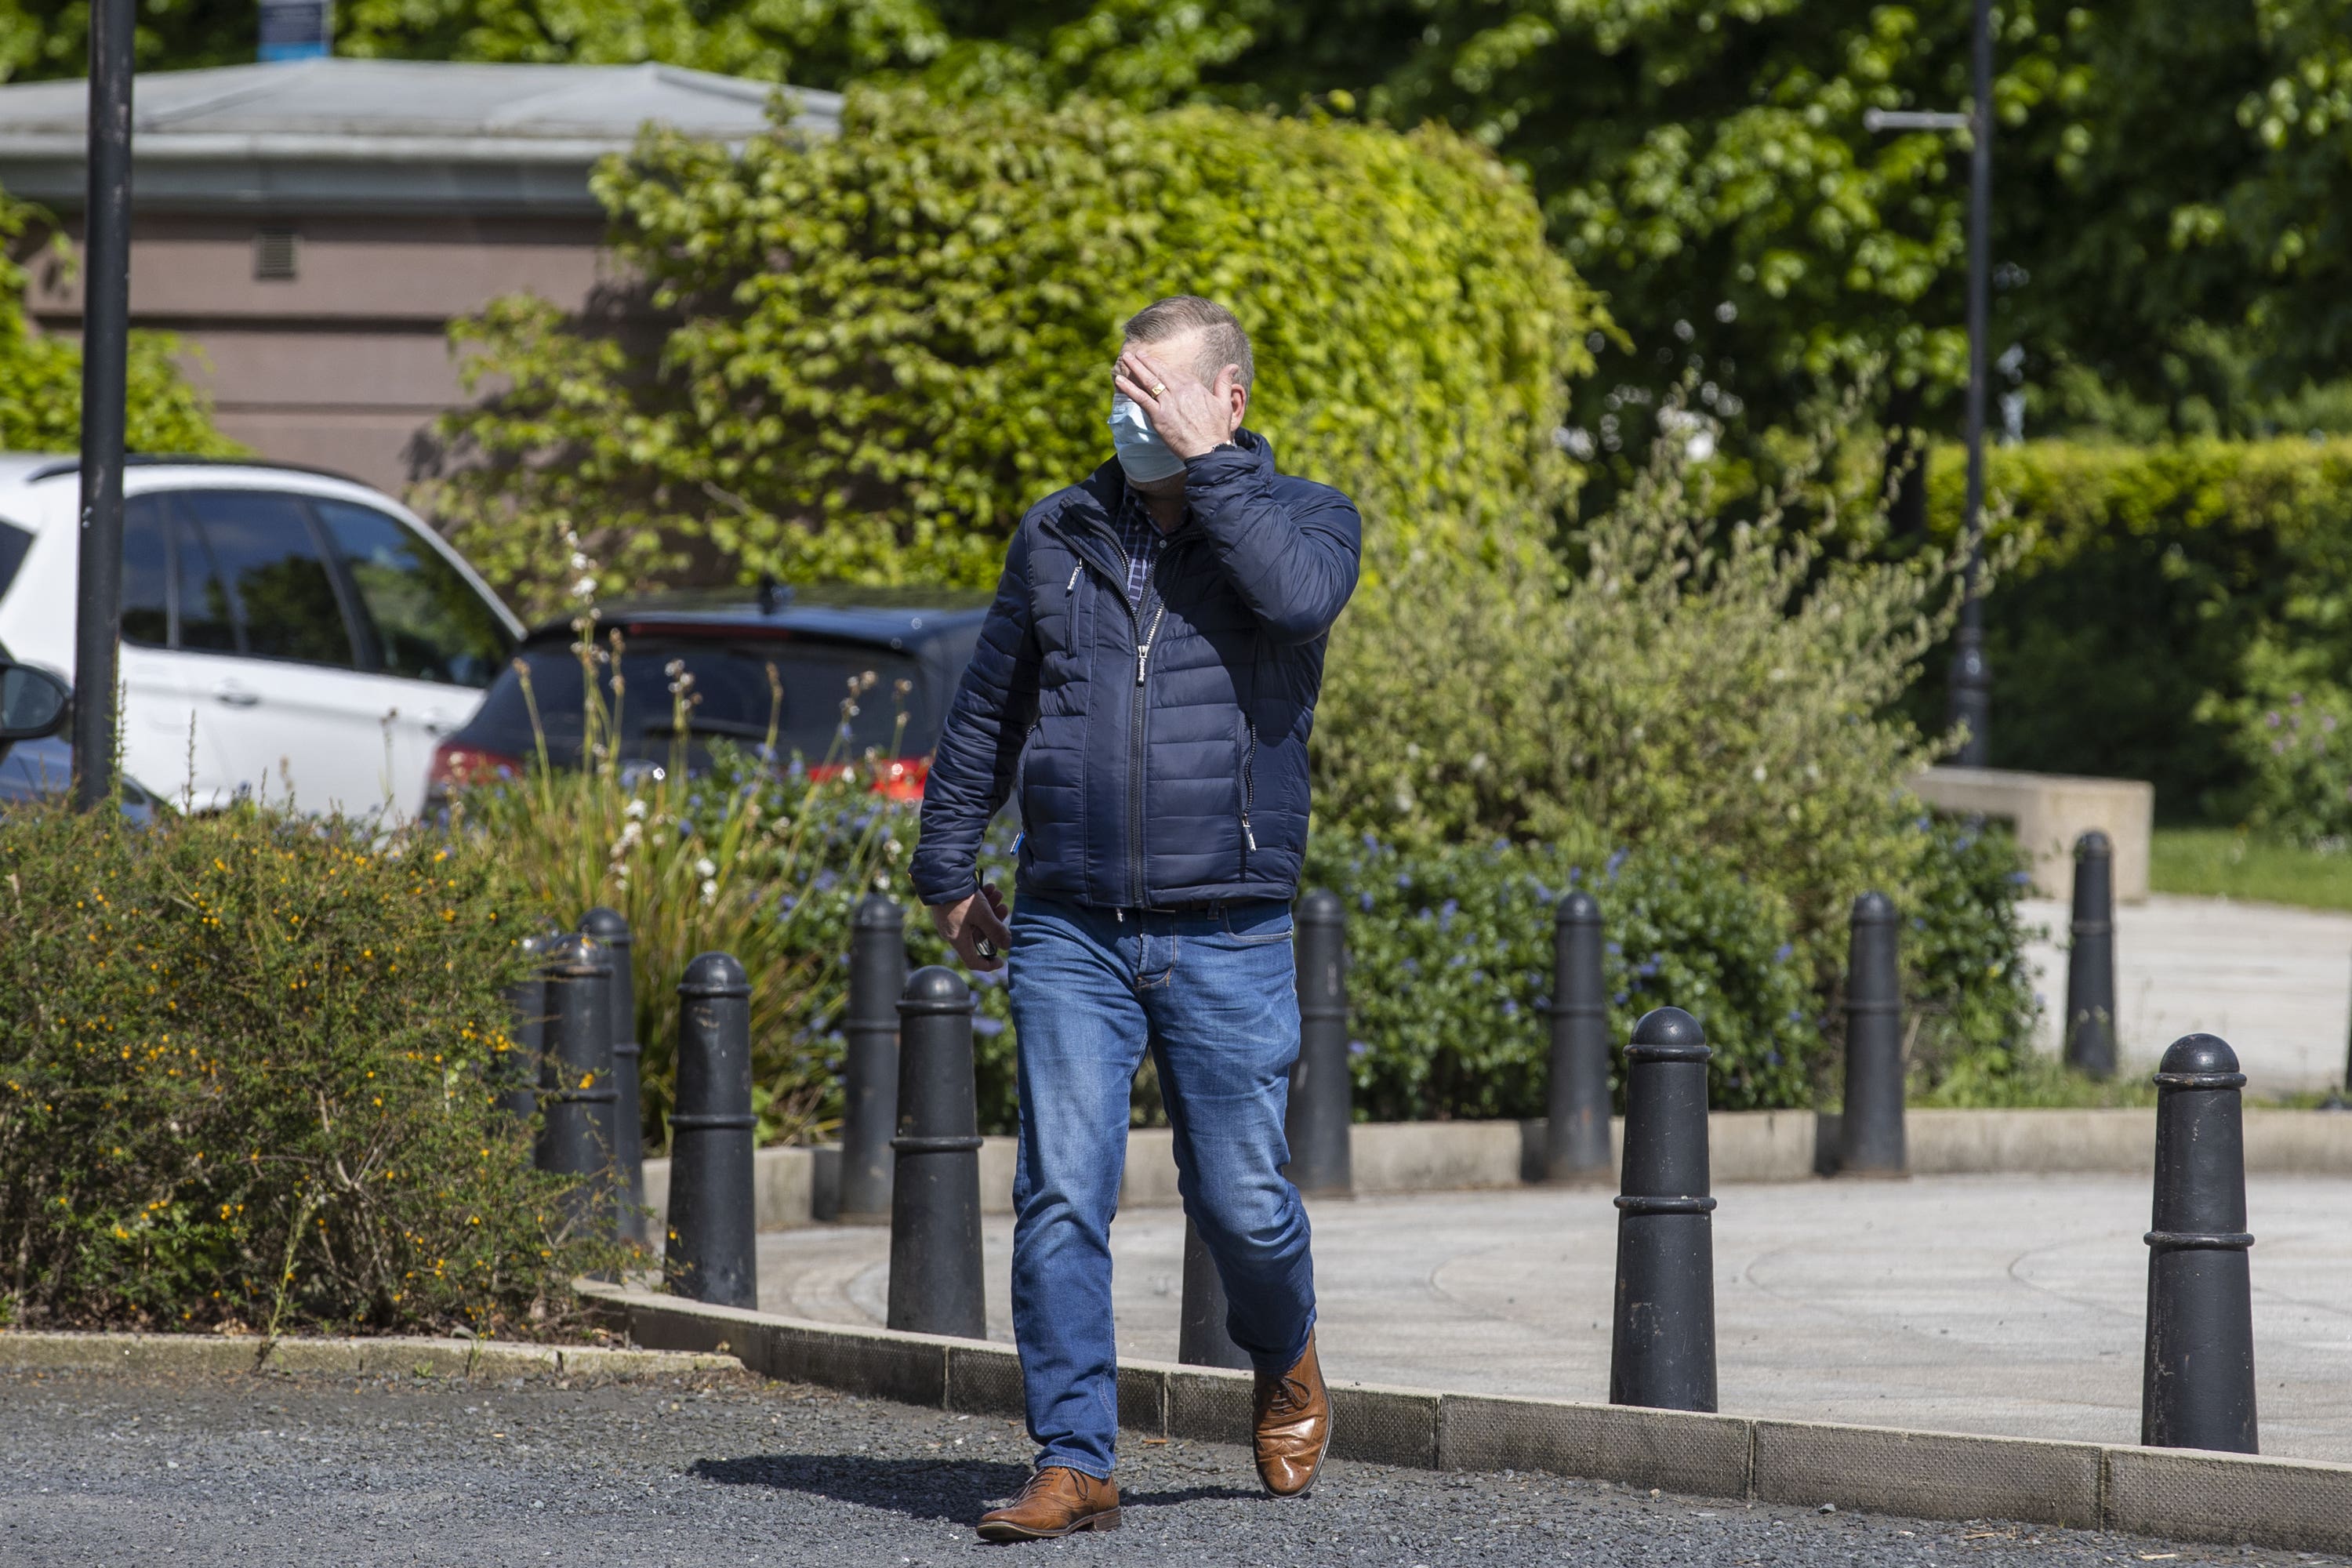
[73,0,139,811]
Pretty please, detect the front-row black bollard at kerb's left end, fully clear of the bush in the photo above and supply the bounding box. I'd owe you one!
[661,952,760,1307]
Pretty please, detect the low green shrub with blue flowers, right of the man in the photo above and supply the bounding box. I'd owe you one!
[1308,818,2037,1121]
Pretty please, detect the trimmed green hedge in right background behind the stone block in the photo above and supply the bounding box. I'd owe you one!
[1922,440,2352,822]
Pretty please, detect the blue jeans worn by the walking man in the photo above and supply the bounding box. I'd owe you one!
[1009,895,1315,1476]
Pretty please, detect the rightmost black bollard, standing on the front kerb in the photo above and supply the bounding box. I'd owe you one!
[2140,1034,2260,1453]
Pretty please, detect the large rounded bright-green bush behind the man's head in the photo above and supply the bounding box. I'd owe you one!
[430,89,1606,602]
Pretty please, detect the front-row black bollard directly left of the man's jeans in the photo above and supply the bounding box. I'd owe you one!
[889,964,988,1340]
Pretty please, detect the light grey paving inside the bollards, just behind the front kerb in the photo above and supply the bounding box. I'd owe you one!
[760,1175,2352,1462]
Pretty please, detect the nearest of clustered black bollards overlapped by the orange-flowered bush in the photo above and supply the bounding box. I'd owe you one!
[539,933,621,1234]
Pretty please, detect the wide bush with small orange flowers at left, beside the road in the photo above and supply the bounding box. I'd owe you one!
[0,806,619,1335]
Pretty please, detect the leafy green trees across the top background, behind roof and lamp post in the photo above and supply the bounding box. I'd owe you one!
[18,0,2352,452]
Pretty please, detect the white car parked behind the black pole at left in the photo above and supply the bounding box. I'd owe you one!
[0,454,522,818]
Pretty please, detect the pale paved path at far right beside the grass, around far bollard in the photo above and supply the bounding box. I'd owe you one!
[2018,893,2352,1095]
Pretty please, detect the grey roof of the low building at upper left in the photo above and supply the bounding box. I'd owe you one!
[0,59,842,212]
